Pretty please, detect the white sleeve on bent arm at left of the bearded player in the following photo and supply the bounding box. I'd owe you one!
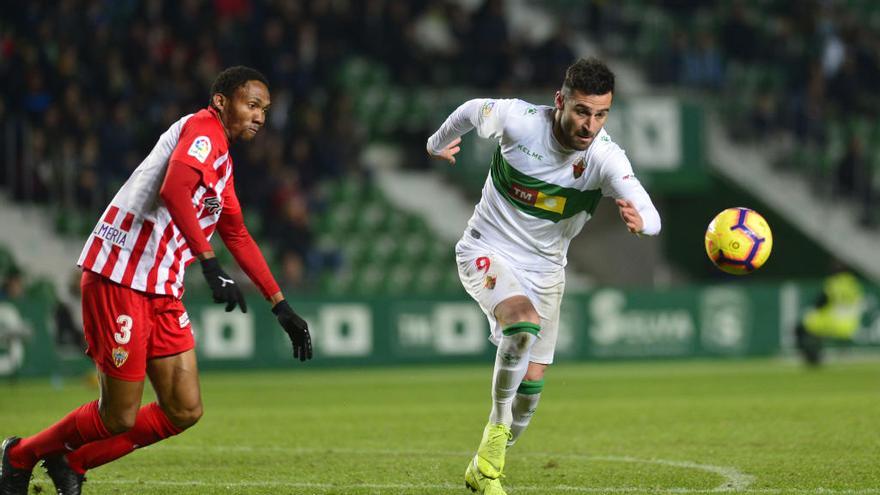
[426,98,508,155]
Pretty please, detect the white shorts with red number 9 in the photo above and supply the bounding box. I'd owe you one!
[455,243,565,364]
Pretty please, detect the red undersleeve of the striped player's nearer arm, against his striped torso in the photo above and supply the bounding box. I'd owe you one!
[159,159,211,256]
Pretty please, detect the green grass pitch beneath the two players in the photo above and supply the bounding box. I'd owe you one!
[0,360,880,495]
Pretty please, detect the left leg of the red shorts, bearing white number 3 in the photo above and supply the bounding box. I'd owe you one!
[81,271,153,382]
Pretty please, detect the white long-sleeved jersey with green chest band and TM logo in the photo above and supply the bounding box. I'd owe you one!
[427,99,660,271]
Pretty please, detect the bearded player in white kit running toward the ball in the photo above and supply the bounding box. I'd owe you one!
[427,58,660,495]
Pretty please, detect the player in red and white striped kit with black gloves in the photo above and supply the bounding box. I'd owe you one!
[0,66,312,495]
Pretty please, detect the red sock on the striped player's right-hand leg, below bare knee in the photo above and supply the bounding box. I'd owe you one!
[67,402,183,474]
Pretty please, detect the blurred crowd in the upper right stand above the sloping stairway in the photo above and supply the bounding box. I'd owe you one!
[586,0,880,226]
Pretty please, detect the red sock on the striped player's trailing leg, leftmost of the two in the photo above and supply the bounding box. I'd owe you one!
[9,401,110,469]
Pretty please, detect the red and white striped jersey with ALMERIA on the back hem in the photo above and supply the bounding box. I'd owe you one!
[77,108,241,298]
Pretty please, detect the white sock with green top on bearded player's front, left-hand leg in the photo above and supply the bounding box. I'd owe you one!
[489,322,541,426]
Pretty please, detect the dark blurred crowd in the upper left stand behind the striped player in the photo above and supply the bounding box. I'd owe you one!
[0,0,573,292]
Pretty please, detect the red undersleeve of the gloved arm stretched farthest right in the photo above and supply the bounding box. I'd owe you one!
[217,188,281,299]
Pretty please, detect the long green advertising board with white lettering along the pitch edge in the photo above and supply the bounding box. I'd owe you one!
[0,284,880,376]
